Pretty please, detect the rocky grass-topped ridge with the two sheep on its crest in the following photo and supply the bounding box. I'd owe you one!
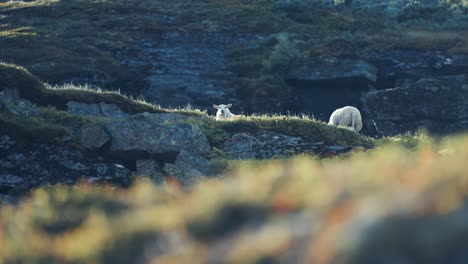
[0,64,374,198]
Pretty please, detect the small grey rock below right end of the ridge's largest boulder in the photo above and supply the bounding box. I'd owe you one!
[163,150,211,185]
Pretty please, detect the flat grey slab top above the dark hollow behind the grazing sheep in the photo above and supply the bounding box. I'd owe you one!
[286,58,377,82]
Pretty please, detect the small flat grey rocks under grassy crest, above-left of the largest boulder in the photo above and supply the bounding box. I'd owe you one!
[67,101,130,118]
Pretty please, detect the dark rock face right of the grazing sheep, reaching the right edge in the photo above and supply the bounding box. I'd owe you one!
[363,75,468,135]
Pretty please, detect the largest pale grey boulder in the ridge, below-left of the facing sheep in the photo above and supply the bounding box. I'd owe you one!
[106,113,210,155]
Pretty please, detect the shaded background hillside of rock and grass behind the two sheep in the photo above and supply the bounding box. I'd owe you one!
[0,0,468,135]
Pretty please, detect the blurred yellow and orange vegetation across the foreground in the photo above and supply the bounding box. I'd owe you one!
[0,136,468,263]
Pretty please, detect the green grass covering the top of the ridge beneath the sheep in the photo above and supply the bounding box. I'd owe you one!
[0,63,374,147]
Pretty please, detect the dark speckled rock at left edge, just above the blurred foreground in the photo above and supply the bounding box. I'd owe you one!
[0,135,130,194]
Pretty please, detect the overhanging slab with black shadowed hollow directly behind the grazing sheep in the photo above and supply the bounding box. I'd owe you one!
[286,58,378,121]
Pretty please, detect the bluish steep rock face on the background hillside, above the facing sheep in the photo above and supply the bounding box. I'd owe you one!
[133,31,252,107]
